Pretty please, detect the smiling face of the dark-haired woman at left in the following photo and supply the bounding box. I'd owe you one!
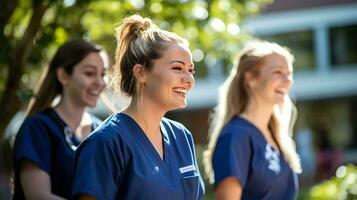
[62,52,105,107]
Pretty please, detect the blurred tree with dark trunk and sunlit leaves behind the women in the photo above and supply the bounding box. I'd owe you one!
[0,0,269,137]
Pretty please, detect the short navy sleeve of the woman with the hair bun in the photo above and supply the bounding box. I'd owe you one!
[72,137,122,199]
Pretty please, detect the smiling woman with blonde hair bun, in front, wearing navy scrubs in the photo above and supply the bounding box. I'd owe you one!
[73,15,204,200]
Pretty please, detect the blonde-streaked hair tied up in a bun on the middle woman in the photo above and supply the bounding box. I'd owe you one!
[113,15,188,96]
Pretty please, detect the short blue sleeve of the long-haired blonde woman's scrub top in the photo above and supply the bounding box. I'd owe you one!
[212,126,252,187]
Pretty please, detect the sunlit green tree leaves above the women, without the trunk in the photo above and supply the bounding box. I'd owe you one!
[0,0,271,97]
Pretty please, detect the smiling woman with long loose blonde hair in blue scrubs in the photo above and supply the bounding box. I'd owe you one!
[204,42,301,200]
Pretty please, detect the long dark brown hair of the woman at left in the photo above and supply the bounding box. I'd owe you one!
[27,38,102,116]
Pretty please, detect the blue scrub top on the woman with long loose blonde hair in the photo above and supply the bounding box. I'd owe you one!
[212,117,298,200]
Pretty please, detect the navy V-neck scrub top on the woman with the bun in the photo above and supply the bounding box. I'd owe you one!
[73,113,204,200]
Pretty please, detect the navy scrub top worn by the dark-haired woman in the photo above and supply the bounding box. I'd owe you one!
[13,109,101,200]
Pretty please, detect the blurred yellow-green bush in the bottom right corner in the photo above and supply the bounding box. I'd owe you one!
[307,164,357,200]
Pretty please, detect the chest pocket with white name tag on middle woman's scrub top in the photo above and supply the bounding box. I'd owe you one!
[180,165,200,200]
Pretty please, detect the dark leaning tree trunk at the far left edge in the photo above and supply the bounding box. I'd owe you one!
[0,1,48,138]
